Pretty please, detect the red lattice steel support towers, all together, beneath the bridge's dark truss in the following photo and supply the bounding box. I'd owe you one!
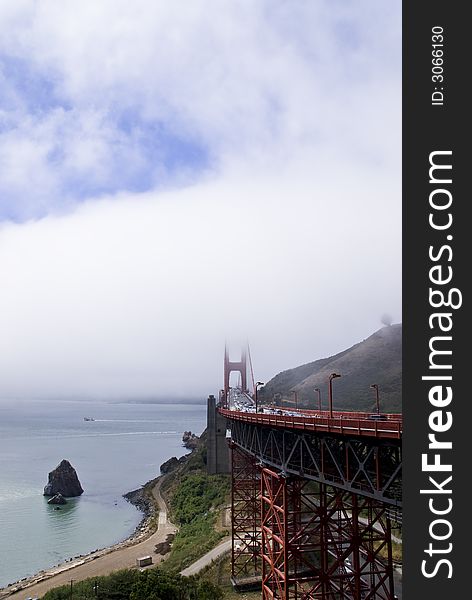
[232,452,394,600]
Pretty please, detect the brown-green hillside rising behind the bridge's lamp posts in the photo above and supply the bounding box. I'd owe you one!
[259,323,402,412]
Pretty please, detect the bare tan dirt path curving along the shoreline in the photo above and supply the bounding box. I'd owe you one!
[0,477,177,600]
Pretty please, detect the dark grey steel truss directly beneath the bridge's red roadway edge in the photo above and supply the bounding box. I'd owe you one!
[230,420,402,510]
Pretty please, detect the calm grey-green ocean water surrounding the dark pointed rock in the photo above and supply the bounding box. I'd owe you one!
[0,401,206,587]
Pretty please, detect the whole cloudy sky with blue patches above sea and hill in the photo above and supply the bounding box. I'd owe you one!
[0,0,401,399]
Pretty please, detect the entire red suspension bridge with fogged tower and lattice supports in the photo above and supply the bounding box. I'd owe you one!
[207,351,402,600]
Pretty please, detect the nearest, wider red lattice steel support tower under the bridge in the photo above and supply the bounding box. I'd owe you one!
[261,468,394,600]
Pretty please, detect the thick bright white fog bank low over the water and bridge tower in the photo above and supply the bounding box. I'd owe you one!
[0,155,400,395]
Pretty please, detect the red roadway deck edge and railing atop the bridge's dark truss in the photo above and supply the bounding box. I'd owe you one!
[218,408,403,440]
